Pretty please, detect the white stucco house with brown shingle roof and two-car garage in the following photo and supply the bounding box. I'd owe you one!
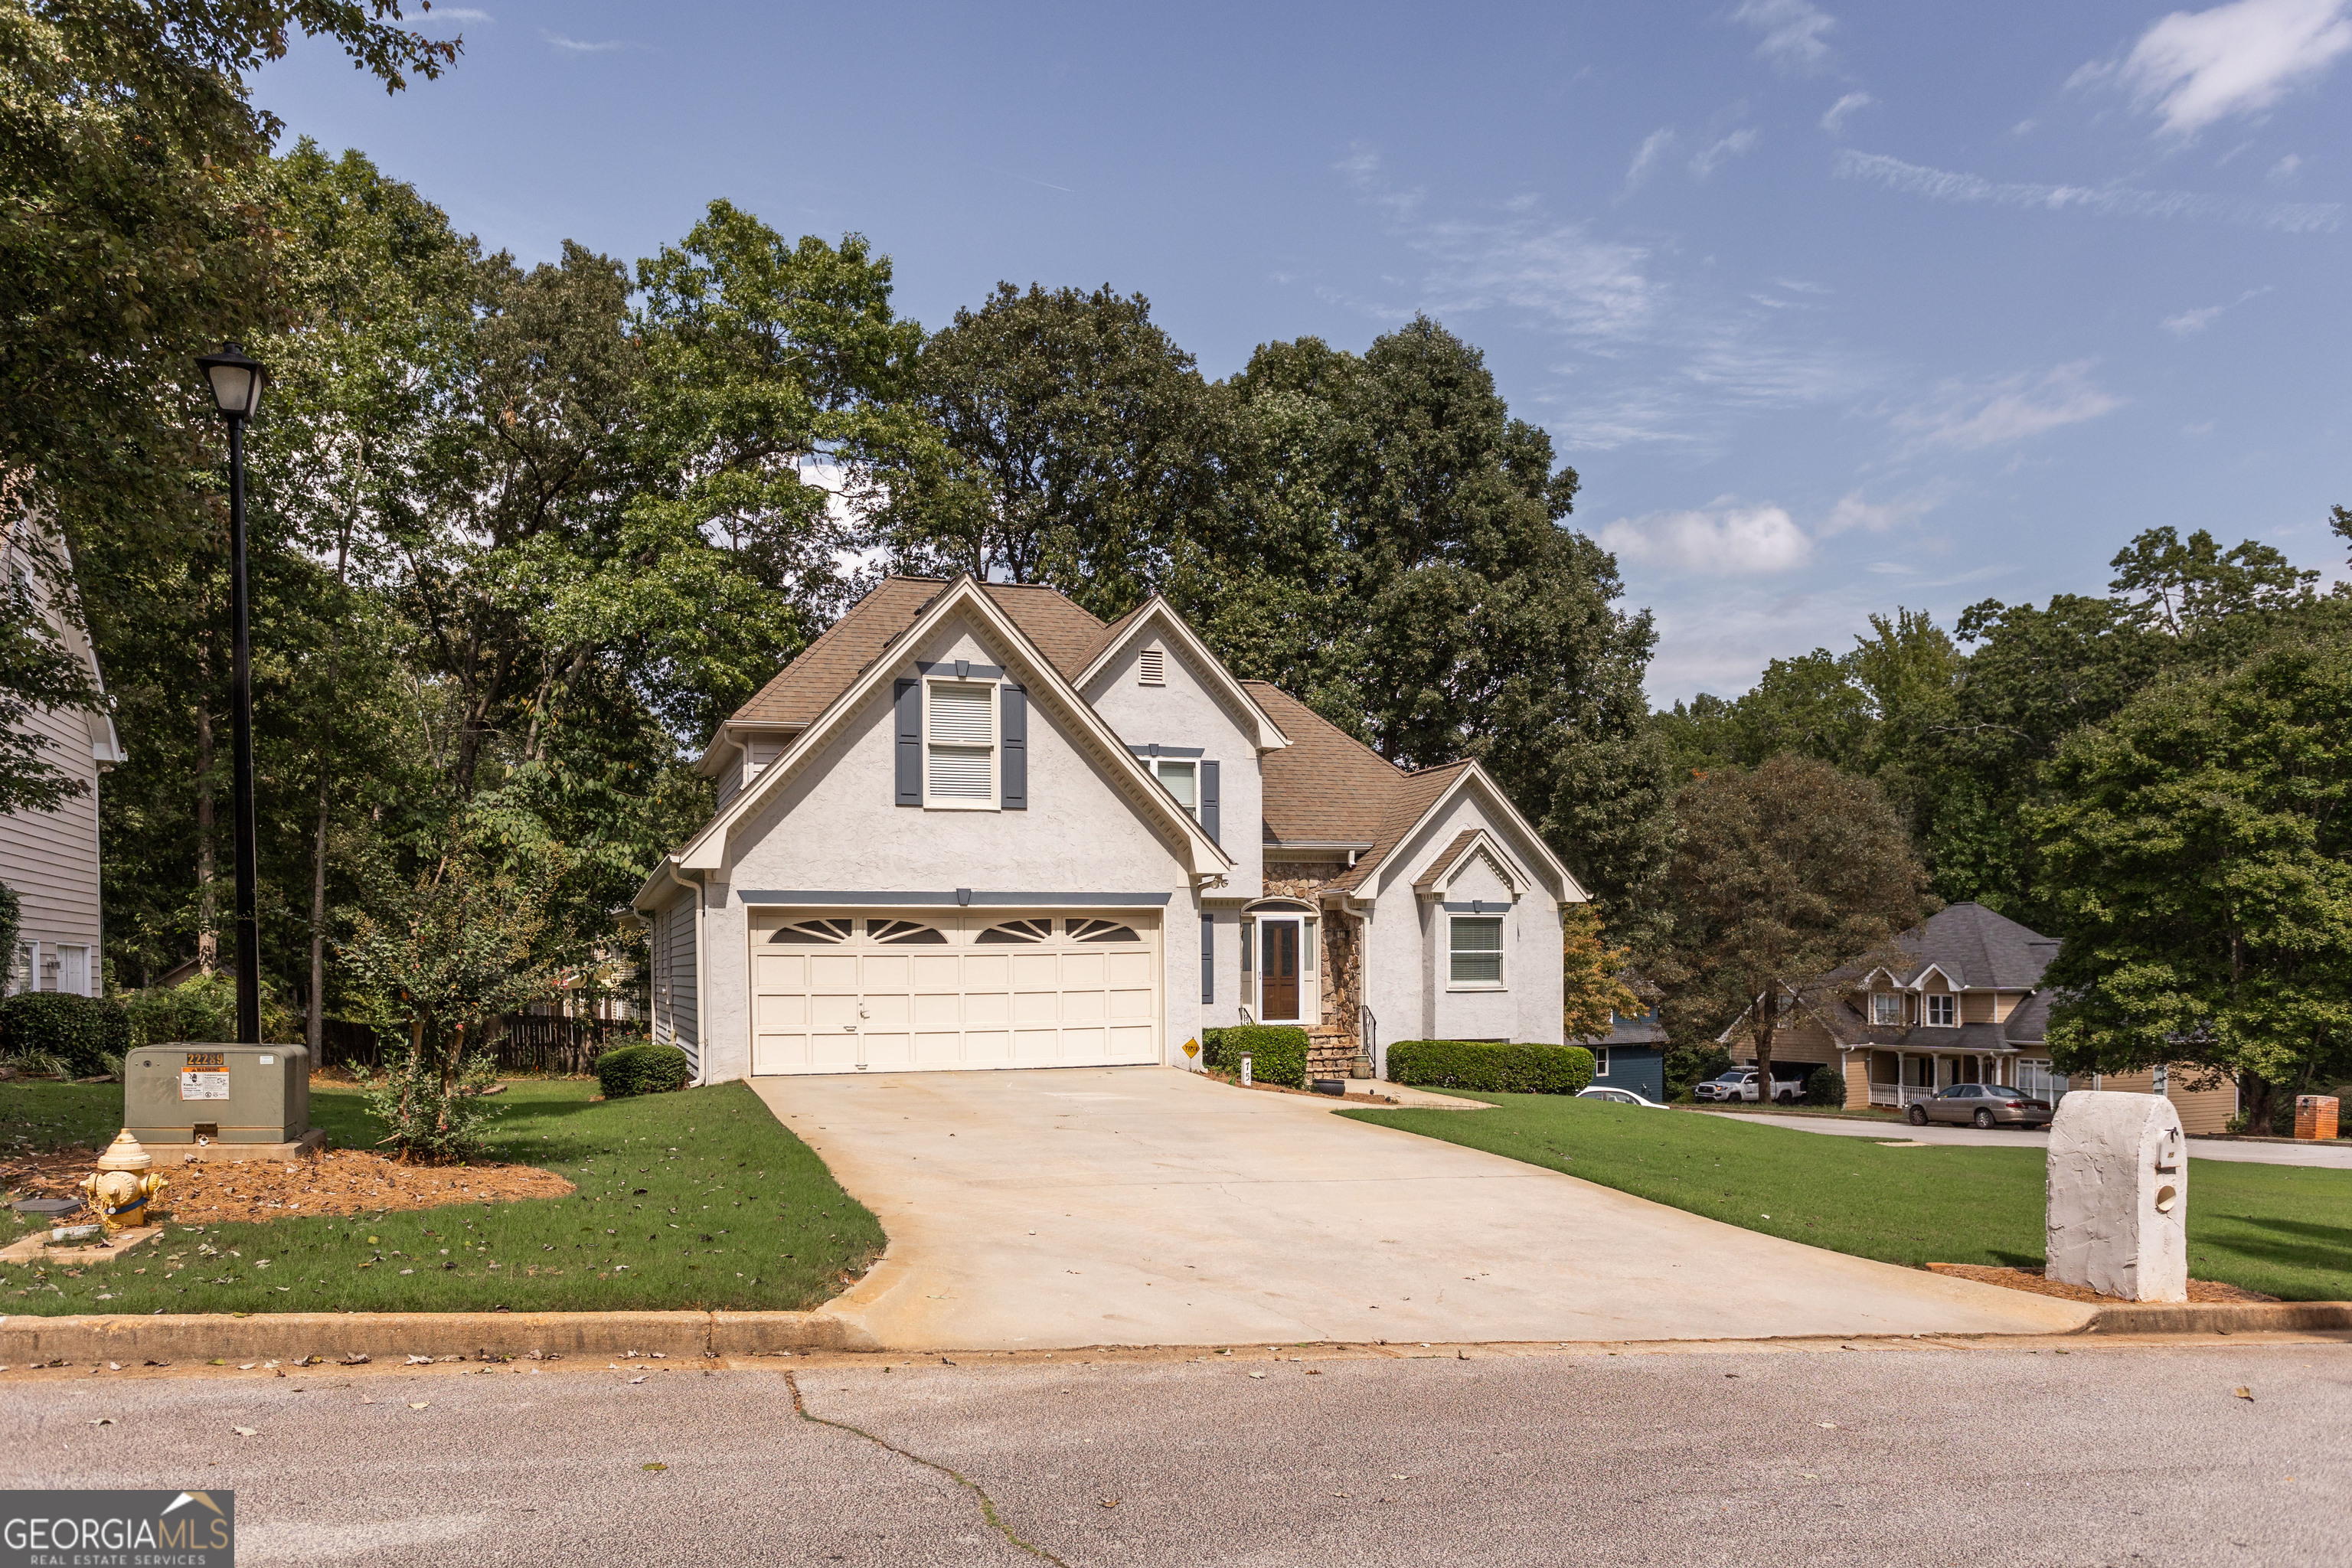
[635,576,1586,1081]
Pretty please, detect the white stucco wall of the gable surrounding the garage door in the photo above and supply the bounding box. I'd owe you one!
[706,626,1194,1079]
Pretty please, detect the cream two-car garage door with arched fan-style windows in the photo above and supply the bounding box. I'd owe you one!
[750,912,1159,1074]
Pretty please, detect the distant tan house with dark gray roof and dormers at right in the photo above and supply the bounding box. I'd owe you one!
[1720,903,2236,1133]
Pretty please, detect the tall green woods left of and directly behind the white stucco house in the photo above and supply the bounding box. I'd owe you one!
[0,0,1668,1062]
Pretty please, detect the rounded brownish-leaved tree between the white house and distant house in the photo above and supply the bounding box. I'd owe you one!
[1648,755,1933,1093]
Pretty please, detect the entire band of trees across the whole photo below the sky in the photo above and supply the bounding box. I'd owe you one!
[0,0,2352,1128]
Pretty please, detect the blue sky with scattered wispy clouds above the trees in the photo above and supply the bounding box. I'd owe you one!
[256,0,2352,701]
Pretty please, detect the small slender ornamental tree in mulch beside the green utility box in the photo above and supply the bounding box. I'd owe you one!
[341,832,564,1159]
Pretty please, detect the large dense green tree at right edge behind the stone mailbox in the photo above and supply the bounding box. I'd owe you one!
[2025,639,2352,1131]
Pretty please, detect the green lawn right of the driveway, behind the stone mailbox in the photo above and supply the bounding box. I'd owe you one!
[1341,1093,2352,1300]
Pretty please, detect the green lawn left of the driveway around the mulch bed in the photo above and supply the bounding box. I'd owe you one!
[0,1079,884,1314]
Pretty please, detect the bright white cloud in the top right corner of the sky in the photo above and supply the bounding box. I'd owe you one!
[2067,0,2352,136]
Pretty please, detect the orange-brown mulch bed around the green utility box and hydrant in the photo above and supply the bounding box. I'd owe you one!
[0,1149,574,1225]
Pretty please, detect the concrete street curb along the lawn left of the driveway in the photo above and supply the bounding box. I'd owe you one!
[0,1312,871,1366]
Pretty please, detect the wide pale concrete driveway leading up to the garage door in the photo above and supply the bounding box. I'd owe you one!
[753,1067,2089,1349]
